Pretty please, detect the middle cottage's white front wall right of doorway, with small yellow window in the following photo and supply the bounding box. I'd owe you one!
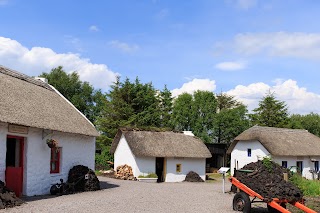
[165,158,206,182]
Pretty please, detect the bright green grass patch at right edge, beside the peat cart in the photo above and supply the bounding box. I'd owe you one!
[290,174,320,196]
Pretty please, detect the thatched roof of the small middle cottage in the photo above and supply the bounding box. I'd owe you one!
[110,129,211,158]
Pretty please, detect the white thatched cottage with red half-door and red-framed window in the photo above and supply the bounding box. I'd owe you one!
[0,66,98,196]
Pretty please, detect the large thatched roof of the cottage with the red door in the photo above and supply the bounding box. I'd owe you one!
[0,66,99,136]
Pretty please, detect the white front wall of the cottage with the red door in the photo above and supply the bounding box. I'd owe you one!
[0,123,95,196]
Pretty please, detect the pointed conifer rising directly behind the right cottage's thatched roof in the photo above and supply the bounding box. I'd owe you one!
[251,92,289,127]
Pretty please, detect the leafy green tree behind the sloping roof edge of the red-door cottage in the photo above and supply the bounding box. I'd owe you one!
[40,66,104,122]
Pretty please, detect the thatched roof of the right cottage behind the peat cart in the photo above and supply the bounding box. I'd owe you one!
[227,126,320,156]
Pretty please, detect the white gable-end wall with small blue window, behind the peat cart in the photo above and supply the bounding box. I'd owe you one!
[230,141,270,175]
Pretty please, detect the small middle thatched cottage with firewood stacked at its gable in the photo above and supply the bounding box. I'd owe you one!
[110,129,211,182]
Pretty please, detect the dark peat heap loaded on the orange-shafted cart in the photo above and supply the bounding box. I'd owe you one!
[236,161,303,202]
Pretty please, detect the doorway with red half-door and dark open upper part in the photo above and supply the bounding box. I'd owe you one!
[6,135,24,197]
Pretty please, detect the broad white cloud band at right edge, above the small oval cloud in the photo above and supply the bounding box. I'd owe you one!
[234,32,320,59]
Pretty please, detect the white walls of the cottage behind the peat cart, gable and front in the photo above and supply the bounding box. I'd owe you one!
[230,141,320,179]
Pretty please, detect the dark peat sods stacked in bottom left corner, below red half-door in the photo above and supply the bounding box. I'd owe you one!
[0,180,24,209]
